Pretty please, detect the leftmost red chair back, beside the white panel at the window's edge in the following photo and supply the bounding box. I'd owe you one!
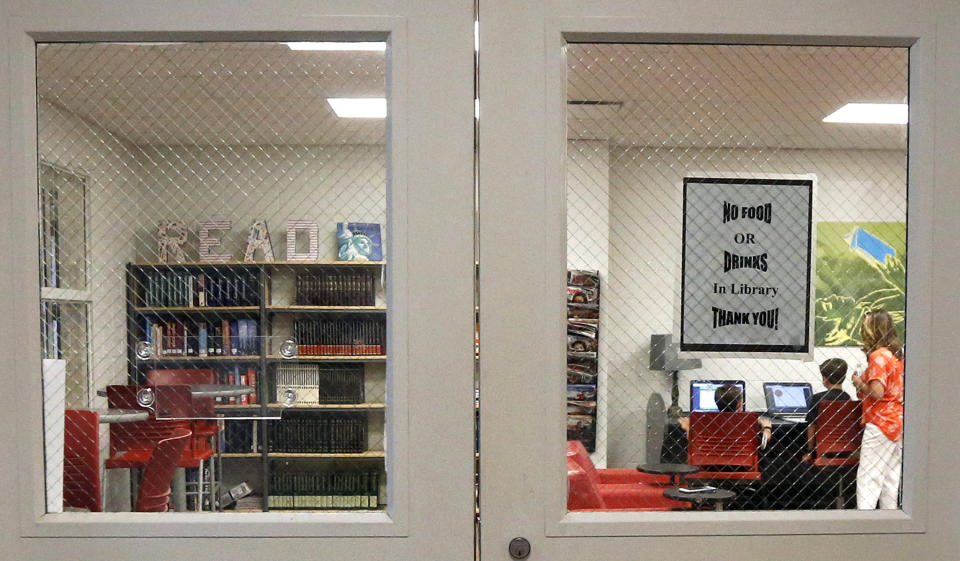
[63,409,103,512]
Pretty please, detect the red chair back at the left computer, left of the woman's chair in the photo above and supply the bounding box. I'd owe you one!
[687,411,760,481]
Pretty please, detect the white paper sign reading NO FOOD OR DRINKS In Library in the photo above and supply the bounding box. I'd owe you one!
[680,177,813,353]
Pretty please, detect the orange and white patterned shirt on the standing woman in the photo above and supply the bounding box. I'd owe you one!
[863,347,903,441]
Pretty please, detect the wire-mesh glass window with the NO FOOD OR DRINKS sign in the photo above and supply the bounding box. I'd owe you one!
[566,44,908,510]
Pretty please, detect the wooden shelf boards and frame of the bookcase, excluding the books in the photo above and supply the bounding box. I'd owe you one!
[126,261,387,511]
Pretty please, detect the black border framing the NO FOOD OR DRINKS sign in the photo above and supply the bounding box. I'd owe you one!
[680,177,814,354]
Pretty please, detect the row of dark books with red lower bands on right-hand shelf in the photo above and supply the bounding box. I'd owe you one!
[293,317,387,356]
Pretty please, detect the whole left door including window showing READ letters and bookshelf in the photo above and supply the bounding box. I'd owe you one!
[0,1,474,559]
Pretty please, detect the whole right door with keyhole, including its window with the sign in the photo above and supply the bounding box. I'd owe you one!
[478,0,960,560]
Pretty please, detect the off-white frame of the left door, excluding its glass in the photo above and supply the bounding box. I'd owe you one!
[0,0,474,559]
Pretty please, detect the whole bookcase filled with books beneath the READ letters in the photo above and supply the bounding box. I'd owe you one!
[127,261,388,510]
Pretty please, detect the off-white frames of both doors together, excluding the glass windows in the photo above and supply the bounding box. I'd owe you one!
[0,0,960,561]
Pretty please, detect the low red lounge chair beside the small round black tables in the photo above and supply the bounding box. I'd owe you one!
[567,458,690,512]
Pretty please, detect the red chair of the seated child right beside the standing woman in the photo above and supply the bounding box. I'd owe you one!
[812,401,863,509]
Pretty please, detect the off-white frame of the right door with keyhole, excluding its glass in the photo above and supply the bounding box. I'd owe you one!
[479,0,958,559]
